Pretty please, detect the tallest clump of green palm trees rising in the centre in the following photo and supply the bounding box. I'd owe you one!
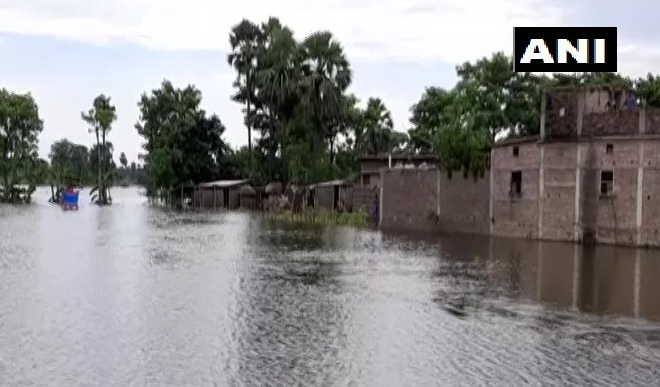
[230,18,360,184]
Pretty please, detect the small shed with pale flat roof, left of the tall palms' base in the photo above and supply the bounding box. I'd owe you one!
[193,179,256,209]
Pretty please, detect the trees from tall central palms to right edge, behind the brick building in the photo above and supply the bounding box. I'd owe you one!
[223,18,660,184]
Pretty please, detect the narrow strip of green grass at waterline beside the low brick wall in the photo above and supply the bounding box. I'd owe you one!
[264,210,369,227]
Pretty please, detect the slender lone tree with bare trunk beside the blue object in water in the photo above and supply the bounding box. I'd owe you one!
[80,94,117,205]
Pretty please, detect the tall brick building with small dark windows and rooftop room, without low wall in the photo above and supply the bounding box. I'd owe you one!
[490,88,660,246]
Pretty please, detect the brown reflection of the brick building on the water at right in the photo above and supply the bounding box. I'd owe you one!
[426,235,660,321]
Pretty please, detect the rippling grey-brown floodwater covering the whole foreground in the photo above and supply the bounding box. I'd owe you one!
[0,189,660,387]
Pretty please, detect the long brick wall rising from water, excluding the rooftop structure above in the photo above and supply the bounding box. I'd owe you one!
[379,135,660,246]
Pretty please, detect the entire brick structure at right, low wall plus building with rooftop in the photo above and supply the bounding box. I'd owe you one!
[378,88,660,246]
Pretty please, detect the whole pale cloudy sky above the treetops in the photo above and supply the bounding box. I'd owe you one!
[0,0,660,161]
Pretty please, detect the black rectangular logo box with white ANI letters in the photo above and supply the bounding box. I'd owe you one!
[513,27,617,73]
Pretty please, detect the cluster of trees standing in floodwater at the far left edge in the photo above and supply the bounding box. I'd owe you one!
[0,89,146,205]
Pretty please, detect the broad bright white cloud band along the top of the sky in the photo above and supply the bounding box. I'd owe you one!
[0,0,565,63]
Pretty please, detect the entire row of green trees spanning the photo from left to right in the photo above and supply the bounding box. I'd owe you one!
[0,18,660,204]
